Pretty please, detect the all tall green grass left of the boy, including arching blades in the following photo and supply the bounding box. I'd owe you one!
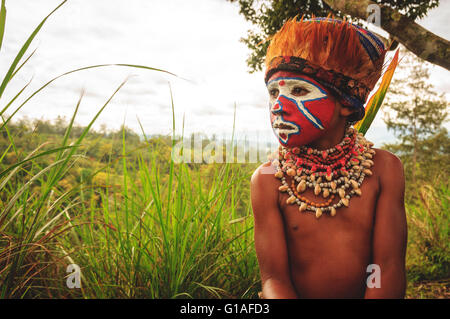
[0,0,258,298]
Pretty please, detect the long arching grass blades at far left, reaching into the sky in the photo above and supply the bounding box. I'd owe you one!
[0,0,184,298]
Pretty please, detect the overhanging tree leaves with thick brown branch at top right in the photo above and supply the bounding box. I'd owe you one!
[228,0,450,72]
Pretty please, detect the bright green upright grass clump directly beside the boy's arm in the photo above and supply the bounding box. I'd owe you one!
[56,138,257,298]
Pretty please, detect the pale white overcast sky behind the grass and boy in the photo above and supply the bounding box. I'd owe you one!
[0,0,450,146]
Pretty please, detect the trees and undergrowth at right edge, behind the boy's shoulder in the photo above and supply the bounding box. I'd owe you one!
[384,54,450,290]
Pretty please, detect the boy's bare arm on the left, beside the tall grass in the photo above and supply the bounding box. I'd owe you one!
[251,164,297,299]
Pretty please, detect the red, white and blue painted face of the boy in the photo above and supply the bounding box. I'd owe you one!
[267,71,335,147]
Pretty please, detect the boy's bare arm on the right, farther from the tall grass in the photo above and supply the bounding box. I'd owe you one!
[365,150,407,298]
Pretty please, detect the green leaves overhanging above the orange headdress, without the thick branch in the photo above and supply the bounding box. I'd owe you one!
[228,0,439,72]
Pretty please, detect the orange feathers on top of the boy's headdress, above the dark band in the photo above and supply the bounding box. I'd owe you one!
[265,17,387,89]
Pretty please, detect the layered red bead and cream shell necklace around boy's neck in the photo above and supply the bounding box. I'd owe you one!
[273,128,375,218]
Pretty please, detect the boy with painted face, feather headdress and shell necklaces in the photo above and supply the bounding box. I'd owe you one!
[251,18,407,298]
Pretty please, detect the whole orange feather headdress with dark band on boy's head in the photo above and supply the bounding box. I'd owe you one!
[265,17,387,121]
